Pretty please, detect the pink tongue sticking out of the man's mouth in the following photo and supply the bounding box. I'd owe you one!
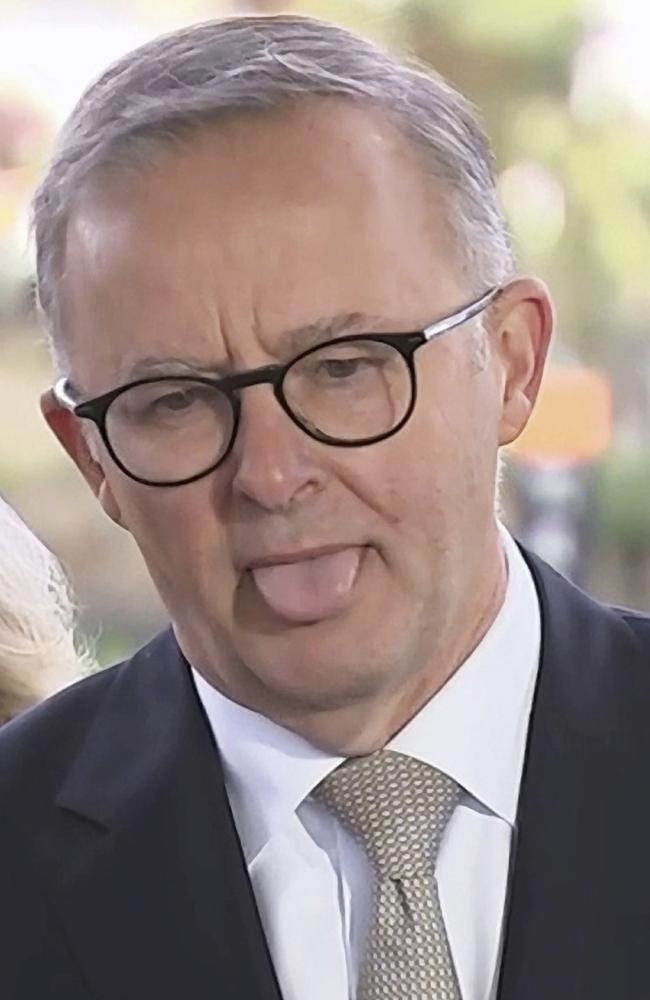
[252,546,362,622]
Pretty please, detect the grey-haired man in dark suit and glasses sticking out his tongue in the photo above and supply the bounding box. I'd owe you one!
[0,16,650,1000]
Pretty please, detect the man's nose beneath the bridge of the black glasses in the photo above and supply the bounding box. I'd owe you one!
[231,386,326,512]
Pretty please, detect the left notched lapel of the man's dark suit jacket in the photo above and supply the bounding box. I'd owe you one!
[40,634,280,1000]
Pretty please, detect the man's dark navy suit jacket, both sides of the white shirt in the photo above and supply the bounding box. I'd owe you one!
[0,556,650,1000]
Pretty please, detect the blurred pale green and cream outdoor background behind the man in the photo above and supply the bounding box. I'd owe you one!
[0,0,650,662]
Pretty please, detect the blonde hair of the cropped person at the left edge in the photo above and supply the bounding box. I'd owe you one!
[0,497,91,725]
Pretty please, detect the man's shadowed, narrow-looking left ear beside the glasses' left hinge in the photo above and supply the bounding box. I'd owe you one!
[41,389,124,527]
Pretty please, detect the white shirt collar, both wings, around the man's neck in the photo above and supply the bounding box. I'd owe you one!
[192,528,541,864]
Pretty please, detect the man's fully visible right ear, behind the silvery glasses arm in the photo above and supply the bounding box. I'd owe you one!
[490,278,554,445]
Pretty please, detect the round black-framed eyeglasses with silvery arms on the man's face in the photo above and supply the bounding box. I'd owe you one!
[54,287,501,486]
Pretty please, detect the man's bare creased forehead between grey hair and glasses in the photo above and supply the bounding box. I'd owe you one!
[61,100,456,381]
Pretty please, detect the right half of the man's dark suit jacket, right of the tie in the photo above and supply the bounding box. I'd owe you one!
[498,556,649,1000]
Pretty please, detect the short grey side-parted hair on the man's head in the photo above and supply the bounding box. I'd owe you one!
[32,15,514,372]
